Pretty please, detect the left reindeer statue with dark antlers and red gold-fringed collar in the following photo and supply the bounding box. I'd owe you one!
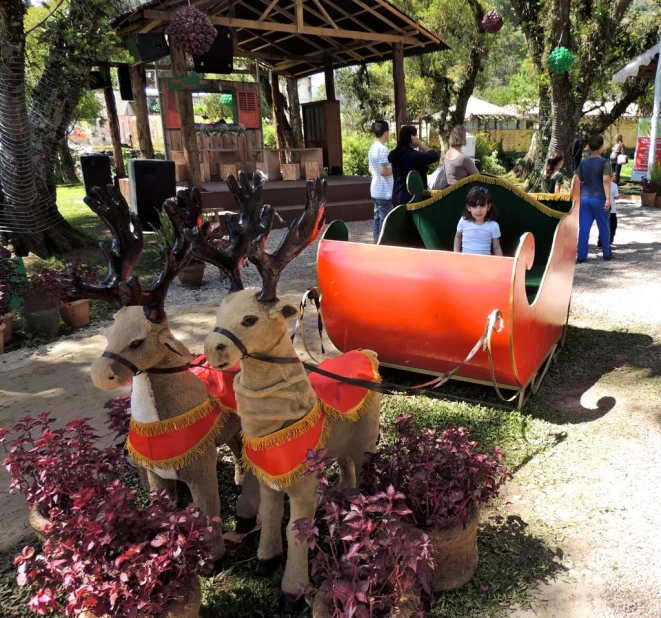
[66,186,263,560]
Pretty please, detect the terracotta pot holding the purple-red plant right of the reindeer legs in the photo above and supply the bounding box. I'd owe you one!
[422,509,480,592]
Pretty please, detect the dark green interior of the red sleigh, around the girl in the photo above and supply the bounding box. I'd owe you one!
[376,172,569,302]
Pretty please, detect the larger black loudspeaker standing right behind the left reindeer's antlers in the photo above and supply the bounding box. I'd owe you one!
[129,159,177,230]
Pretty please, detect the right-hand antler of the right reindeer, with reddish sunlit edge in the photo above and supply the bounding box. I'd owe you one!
[248,178,327,303]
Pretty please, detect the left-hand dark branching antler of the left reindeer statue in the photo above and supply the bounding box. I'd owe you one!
[62,185,143,307]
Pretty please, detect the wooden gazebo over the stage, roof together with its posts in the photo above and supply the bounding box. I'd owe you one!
[113,0,447,184]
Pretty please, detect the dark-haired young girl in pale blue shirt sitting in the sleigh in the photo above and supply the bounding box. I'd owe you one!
[454,187,503,255]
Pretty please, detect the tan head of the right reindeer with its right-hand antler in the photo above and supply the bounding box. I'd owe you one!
[204,174,326,368]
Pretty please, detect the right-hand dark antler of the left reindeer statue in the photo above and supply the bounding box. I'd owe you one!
[140,187,202,322]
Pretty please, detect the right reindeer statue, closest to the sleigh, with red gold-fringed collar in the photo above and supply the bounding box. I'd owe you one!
[193,179,381,613]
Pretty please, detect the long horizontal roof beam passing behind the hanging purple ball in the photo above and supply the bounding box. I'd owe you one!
[144,9,421,45]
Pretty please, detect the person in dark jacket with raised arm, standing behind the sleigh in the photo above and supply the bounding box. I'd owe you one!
[388,125,439,206]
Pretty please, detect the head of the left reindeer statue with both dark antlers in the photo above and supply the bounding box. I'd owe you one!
[65,185,201,390]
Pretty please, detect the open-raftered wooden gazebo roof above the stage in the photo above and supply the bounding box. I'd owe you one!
[113,0,448,77]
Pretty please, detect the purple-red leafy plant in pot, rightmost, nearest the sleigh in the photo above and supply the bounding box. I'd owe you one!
[363,415,512,530]
